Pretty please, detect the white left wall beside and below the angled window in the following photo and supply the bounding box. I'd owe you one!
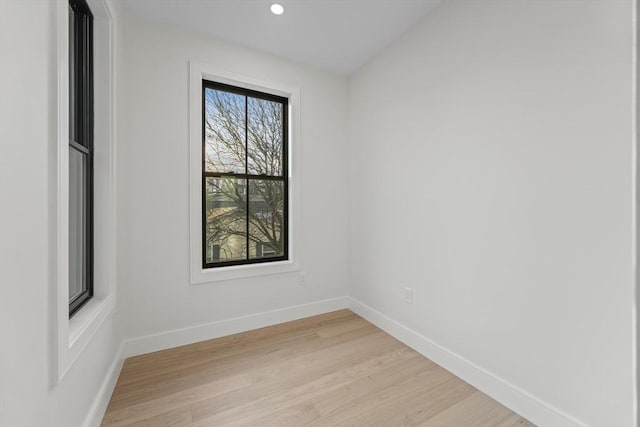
[0,1,121,427]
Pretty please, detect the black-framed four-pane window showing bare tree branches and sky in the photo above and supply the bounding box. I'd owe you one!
[202,80,289,268]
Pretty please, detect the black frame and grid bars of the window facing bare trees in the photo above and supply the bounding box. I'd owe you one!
[201,79,289,269]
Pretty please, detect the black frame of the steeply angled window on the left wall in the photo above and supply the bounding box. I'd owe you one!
[69,0,94,318]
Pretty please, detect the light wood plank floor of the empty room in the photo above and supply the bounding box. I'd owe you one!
[102,310,532,427]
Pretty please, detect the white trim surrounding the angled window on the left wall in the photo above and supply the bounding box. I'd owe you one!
[50,0,116,384]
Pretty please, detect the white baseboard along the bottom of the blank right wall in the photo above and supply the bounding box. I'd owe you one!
[349,298,587,427]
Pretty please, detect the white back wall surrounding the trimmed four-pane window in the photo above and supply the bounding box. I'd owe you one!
[118,16,348,344]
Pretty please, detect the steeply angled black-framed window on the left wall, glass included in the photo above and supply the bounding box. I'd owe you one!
[69,0,93,317]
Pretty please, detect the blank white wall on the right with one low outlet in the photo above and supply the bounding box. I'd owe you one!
[349,0,634,427]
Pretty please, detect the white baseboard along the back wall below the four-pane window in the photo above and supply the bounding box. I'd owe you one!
[124,296,349,358]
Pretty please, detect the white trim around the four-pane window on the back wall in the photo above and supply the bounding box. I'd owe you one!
[189,61,302,284]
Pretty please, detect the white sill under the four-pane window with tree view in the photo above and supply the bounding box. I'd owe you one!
[191,260,300,285]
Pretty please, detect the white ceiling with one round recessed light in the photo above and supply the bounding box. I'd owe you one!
[123,0,442,74]
